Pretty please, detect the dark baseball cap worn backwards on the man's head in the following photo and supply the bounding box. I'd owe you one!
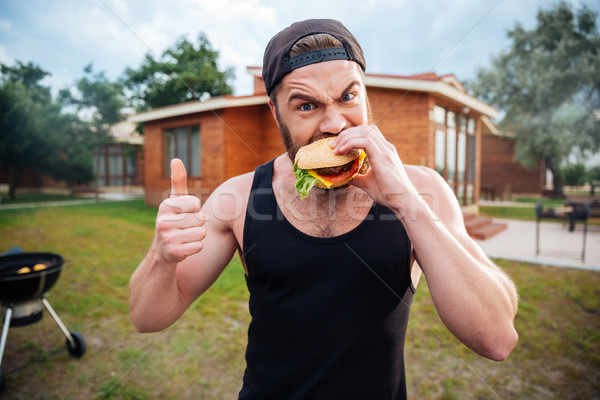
[262,19,366,95]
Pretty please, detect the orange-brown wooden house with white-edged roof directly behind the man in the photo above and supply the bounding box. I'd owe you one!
[129,67,498,219]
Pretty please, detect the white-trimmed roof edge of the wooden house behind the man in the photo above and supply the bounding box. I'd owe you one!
[127,67,498,123]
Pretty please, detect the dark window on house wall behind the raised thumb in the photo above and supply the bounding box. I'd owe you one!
[164,125,202,177]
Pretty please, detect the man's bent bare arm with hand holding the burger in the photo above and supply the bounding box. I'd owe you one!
[336,126,518,360]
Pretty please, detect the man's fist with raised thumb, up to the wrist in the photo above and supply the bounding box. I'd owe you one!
[155,158,206,264]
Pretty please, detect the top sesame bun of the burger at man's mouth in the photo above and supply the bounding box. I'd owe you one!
[295,136,360,169]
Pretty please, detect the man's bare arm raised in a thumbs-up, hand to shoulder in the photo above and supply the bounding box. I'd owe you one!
[129,161,248,332]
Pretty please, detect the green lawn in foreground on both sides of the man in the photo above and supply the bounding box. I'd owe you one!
[0,201,600,400]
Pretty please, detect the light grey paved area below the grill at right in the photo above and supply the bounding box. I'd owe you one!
[477,218,600,271]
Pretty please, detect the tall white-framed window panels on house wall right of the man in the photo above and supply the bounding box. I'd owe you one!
[433,105,476,205]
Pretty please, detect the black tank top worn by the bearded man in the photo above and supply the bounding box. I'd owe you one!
[239,161,414,400]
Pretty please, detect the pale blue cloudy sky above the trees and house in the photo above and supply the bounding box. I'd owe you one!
[0,0,600,95]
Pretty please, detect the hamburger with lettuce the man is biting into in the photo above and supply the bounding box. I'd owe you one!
[294,136,368,198]
